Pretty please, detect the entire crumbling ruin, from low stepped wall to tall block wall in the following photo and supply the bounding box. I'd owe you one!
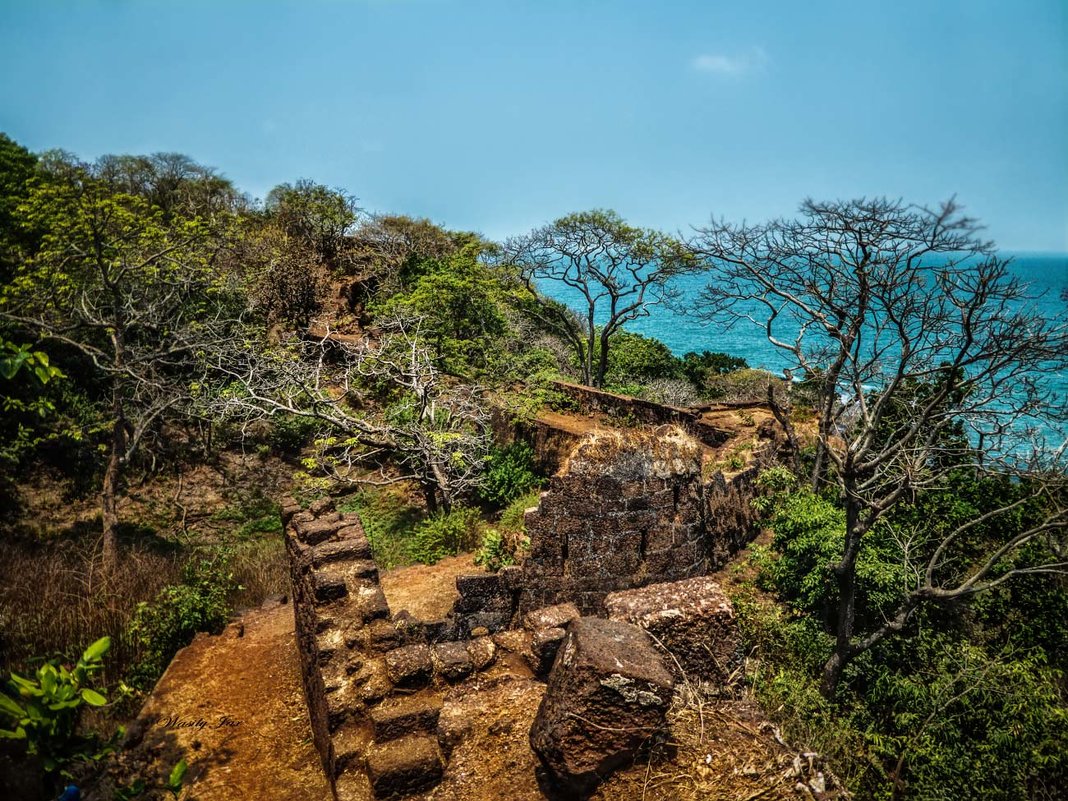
[283,410,786,801]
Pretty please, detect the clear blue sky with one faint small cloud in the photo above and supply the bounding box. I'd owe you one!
[0,0,1068,251]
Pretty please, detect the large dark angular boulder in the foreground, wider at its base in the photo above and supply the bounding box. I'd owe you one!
[531,617,674,797]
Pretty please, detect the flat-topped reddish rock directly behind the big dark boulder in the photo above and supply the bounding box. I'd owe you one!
[604,576,740,680]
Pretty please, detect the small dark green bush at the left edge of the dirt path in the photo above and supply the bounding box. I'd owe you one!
[126,551,239,689]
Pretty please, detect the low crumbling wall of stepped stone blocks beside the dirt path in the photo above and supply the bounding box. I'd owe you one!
[282,500,515,801]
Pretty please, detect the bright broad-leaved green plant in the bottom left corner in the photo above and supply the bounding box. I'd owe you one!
[0,637,123,776]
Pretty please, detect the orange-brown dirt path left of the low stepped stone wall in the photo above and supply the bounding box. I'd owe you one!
[128,604,331,801]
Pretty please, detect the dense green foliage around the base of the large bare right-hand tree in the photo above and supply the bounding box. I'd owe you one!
[740,469,1068,799]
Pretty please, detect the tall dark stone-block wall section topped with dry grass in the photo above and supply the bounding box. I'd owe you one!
[516,427,707,614]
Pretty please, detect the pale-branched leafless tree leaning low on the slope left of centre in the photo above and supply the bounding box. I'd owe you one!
[205,318,492,512]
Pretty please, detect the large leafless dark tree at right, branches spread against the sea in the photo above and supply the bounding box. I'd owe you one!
[692,200,1068,695]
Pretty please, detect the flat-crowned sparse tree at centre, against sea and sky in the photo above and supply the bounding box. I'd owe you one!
[498,210,692,387]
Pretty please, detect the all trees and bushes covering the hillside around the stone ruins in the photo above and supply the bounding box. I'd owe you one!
[0,136,1068,800]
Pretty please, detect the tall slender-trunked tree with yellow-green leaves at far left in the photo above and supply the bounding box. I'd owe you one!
[0,154,237,566]
